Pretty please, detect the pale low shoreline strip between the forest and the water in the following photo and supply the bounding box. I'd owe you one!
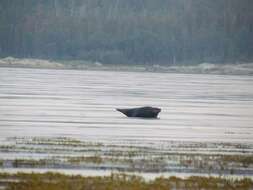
[0,57,253,75]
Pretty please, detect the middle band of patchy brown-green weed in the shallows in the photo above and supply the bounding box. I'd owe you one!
[0,153,253,174]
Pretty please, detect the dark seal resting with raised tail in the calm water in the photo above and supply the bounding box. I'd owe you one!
[116,107,161,118]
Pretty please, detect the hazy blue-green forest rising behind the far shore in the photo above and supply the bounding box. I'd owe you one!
[0,0,253,64]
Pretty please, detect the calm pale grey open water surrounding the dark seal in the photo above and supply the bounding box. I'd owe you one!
[0,68,253,143]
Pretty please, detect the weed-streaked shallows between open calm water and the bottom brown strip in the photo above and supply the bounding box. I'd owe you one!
[0,137,253,177]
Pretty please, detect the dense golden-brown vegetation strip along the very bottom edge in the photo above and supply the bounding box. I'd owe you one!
[0,173,253,190]
